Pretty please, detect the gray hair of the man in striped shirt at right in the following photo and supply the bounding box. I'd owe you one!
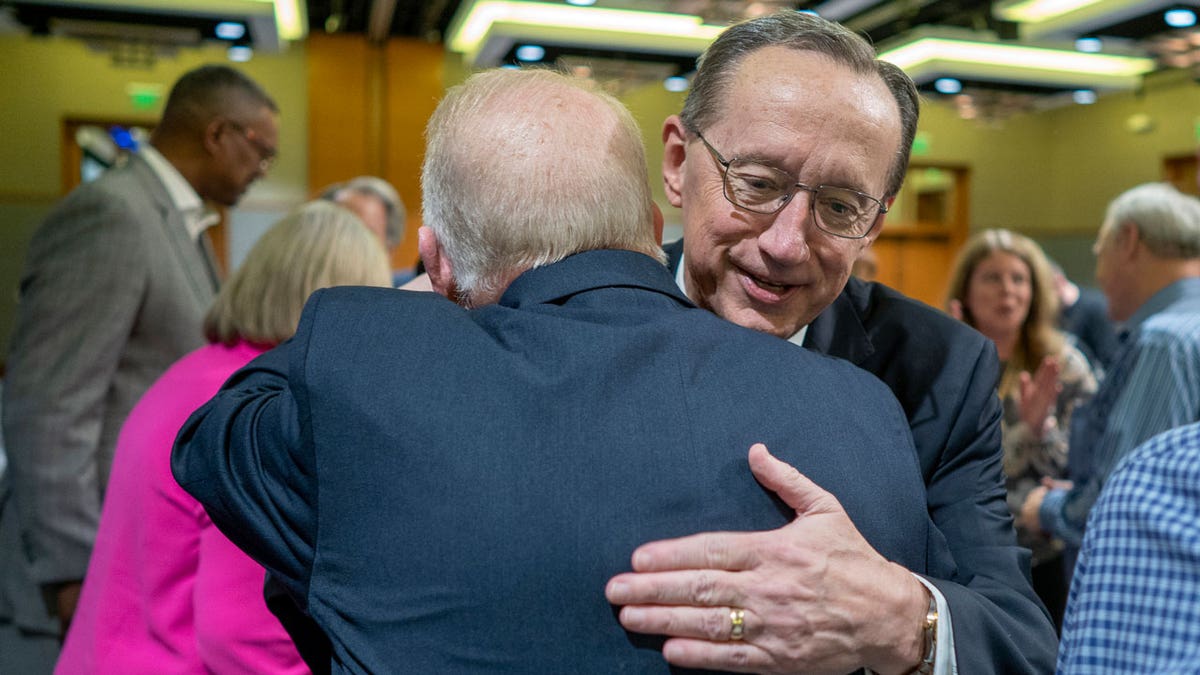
[1102,183,1200,258]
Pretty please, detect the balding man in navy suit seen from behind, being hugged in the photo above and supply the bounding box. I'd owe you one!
[173,70,949,674]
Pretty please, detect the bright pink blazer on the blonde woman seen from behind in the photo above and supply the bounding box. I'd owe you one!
[55,344,307,675]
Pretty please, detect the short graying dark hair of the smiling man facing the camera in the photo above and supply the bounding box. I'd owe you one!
[679,11,920,197]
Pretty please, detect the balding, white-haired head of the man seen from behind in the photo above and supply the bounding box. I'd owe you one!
[421,70,665,305]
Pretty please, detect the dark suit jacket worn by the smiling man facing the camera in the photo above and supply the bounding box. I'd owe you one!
[665,241,1057,675]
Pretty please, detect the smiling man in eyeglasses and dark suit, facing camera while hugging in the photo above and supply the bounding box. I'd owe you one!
[607,12,1056,674]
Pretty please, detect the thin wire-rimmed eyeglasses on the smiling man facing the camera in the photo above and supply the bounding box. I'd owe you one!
[696,131,888,239]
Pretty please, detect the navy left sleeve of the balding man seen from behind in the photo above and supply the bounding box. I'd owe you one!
[172,292,319,609]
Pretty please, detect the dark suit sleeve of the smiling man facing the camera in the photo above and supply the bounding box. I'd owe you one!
[928,341,1057,674]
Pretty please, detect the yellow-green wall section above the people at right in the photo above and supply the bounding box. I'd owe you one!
[916,71,1200,278]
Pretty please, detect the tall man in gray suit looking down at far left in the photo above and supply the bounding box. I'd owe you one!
[0,65,278,674]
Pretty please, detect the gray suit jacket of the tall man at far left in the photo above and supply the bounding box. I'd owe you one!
[0,155,216,633]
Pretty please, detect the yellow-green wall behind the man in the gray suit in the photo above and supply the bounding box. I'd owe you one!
[0,35,308,352]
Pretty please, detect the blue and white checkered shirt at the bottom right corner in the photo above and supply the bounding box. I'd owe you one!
[1058,424,1200,674]
